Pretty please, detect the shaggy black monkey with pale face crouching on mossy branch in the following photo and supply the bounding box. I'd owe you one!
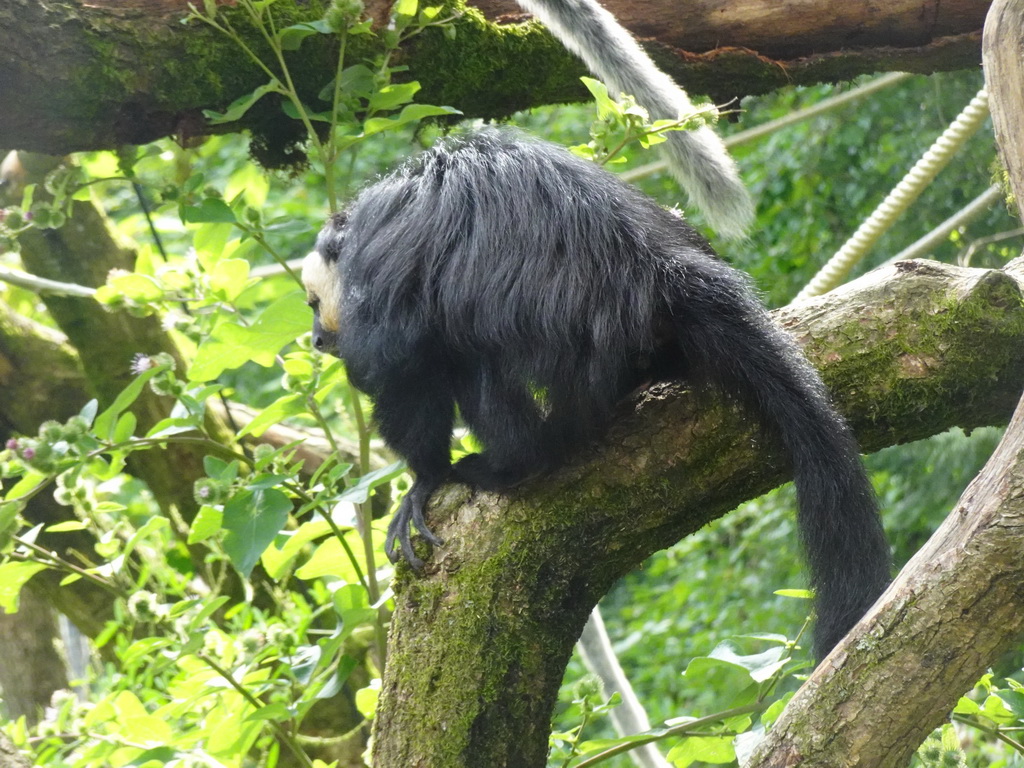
[307,129,889,655]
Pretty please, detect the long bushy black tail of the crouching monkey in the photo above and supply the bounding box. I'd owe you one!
[673,263,890,659]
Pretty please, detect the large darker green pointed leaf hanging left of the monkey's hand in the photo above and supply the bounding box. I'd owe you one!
[221,488,292,578]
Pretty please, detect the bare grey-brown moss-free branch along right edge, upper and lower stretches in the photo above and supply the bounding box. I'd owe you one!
[750,0,1024,768]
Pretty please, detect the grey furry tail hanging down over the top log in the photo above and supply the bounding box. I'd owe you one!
[517,0,754,237]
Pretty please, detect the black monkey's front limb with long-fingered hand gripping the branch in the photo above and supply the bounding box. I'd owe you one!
[374,376,454,570]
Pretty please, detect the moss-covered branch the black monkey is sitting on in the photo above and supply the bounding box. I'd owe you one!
[375,260,1024,768]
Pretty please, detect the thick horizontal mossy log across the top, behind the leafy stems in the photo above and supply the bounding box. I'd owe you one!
[0,0,988,155]
